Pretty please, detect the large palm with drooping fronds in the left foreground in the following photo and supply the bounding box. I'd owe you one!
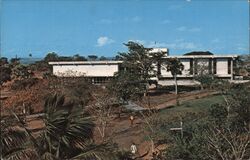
[10,94,117,160]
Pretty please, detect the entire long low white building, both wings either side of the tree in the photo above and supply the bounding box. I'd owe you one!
[49,50,238,83]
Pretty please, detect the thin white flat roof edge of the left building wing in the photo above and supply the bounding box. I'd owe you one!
[49,61,122,65]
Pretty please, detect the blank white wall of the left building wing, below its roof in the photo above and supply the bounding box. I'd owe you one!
[53,64,118,77]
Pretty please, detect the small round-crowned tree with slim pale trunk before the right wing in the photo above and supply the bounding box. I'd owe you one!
[163,58,184,94]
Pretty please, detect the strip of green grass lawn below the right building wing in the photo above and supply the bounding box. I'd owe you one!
[159,95,224,116]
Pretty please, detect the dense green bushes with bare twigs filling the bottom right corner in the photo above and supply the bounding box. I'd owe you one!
[165,86,250,160]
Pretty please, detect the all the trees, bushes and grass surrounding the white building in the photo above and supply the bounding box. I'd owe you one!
[0,49,250,160]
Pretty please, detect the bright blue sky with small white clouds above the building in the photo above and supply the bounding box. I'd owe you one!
[0,0,250,58]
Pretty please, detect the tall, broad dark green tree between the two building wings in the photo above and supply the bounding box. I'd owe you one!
[110,41,164,106]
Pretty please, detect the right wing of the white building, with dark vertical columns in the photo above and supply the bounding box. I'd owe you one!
[161,55,238,79]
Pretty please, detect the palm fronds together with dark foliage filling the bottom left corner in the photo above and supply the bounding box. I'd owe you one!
[1,94,119,159]
